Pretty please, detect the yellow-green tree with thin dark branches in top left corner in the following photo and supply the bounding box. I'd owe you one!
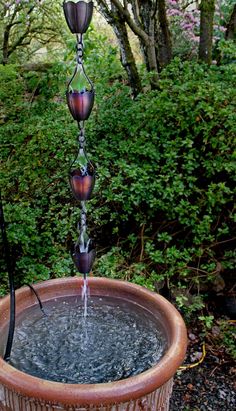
[0,0,61,64]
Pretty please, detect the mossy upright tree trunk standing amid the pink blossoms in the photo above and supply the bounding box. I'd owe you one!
[198,0,215,64]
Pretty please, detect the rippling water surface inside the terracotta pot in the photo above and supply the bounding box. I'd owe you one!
[11,297,167,384]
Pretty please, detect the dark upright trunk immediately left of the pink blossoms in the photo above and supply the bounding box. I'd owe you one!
[157,0,172,67]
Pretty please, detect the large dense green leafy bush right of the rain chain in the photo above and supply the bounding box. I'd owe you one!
[89,61,235,305]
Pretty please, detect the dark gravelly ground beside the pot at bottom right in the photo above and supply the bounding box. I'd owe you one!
[170,348,236,411]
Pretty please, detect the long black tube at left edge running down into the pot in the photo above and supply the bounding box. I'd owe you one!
[0,192,16,362]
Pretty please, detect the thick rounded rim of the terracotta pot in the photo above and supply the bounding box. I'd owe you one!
[0,277,187,406]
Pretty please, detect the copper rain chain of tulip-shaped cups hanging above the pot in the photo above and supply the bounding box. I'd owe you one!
[63,0,95,280]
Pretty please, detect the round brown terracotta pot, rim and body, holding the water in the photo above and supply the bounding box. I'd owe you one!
[0,278,187,411]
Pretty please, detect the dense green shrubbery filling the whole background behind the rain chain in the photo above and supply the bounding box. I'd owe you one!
[0,54,235,318]
